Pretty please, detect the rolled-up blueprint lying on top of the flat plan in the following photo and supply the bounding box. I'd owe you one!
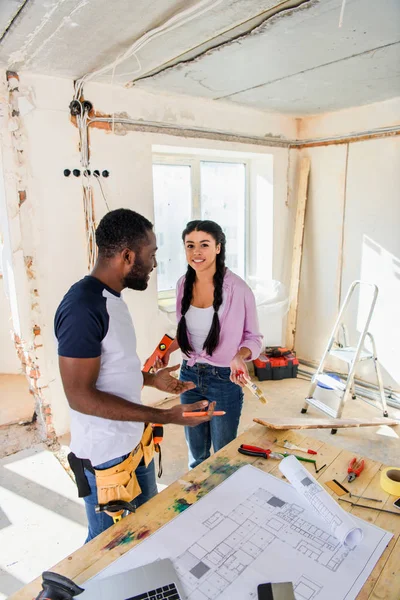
[279,455,363,550]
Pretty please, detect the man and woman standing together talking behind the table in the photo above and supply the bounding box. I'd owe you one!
[54,209,261,541]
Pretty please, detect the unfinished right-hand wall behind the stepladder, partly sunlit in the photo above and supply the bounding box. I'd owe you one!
[296,99,400,390]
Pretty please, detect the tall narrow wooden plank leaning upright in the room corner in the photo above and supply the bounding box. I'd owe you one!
[286,156,311,350]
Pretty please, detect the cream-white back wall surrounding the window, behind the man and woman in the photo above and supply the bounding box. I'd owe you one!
[10,75,296,434]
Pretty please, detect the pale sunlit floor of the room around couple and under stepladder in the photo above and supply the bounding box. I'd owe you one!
[0,379,400,600]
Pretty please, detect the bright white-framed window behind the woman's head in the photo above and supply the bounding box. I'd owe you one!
[153,155,248,297]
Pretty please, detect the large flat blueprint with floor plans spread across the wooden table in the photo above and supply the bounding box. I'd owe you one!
[96,465,392,600]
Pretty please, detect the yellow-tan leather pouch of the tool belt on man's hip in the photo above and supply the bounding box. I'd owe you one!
[94,425,154,504]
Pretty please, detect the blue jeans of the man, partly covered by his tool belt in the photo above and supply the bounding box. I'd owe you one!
[84,454,157,544]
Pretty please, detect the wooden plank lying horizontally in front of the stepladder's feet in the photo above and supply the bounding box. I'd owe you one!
[253,417,400,429]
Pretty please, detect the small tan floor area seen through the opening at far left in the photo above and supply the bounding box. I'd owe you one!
[0,373,34,426]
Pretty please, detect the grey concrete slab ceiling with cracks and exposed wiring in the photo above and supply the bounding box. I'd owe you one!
[0,0,400,116]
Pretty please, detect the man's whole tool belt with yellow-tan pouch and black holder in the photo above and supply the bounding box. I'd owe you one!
[68,424,154,505]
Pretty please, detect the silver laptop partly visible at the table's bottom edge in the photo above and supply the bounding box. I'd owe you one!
[79,558,187,600]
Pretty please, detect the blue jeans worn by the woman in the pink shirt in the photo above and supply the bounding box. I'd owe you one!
[180,360,243,469]
